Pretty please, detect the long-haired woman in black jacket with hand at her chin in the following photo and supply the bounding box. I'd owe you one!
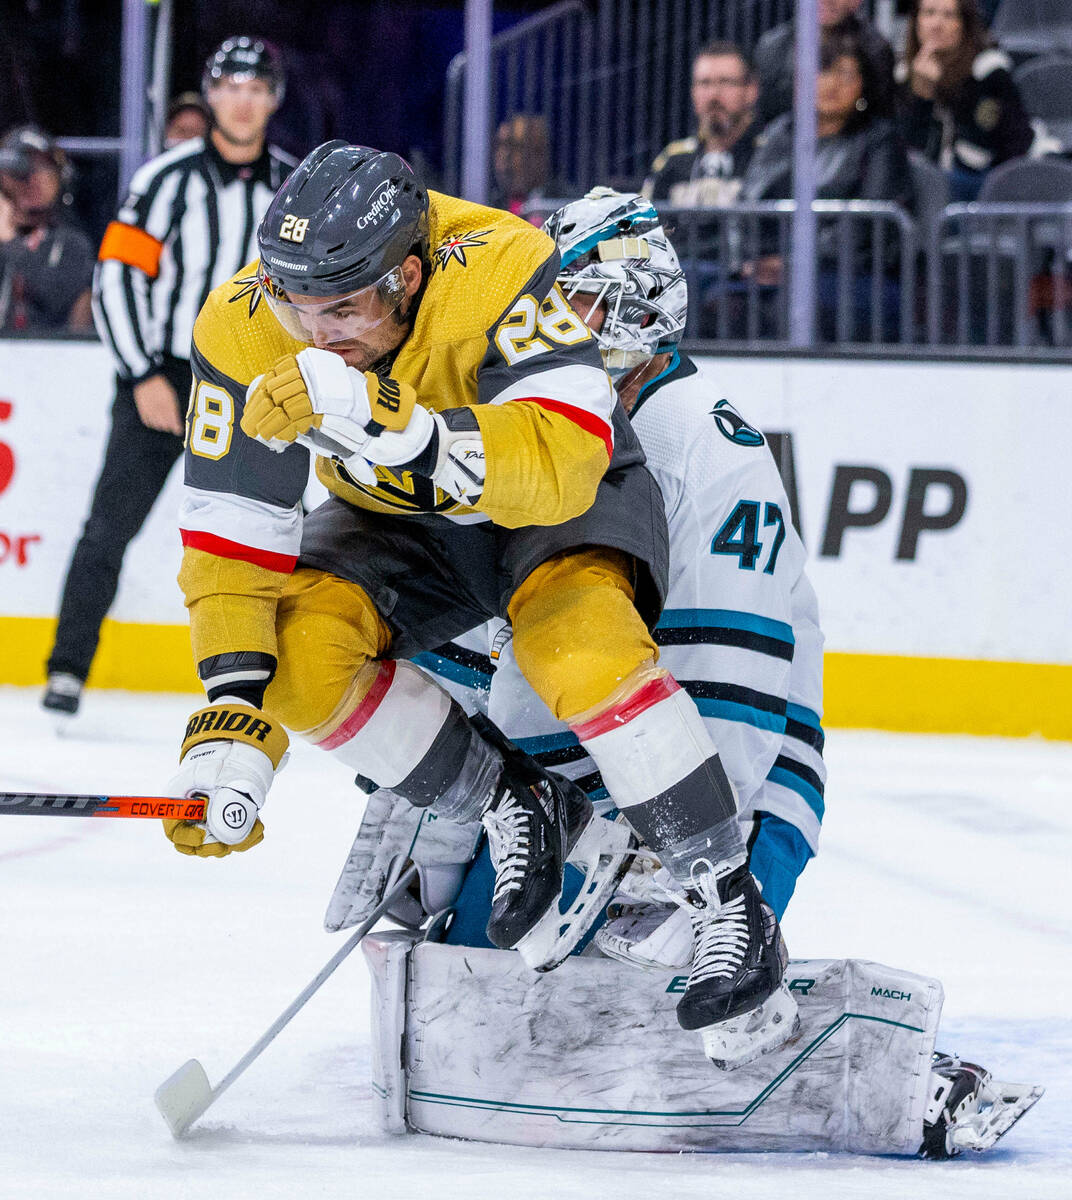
[897,0,1035,200]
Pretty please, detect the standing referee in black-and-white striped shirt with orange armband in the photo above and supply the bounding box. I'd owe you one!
[42,37,295,716]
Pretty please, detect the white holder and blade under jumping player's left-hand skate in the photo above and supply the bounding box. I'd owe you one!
[514,816,636,971]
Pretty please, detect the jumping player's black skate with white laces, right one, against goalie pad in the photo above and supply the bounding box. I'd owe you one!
[677,862,799,1070]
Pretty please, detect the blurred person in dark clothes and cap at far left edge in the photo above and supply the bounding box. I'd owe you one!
[0,125,95,334]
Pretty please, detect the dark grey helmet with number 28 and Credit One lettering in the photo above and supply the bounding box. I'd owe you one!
[257,140,429,341]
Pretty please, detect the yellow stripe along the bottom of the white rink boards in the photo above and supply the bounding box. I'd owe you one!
[0,617,1072,740]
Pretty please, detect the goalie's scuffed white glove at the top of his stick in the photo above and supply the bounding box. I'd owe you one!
[324,787,483,931]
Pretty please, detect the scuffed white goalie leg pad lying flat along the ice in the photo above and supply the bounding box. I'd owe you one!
[363,932,942,1154]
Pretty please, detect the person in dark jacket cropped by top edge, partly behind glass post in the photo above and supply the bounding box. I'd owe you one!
[755,0,894,124]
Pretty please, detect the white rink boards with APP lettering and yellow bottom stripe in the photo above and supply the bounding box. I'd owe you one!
[0,341,1072,738]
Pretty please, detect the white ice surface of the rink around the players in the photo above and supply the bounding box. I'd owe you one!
[0,689,1072,1200]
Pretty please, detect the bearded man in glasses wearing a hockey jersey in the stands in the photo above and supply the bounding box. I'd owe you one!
[643,42,760,208]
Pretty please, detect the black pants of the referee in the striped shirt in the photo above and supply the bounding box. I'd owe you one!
[48,358,190,679]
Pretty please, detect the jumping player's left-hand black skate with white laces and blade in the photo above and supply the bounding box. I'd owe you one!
[472,716,635,971]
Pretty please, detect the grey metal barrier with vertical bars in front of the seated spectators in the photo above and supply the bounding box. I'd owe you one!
[523,199,1072,361]
